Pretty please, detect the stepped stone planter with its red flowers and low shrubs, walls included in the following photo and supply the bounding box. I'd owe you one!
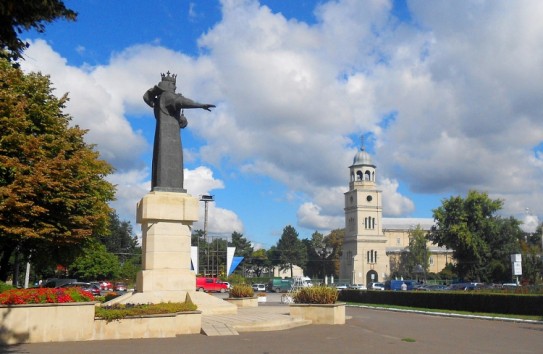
[0,288,202,344]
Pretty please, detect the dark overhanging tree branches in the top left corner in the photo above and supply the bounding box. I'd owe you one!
[0,0,77,61]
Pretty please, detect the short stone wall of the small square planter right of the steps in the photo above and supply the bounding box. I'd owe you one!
[289,302,345,324]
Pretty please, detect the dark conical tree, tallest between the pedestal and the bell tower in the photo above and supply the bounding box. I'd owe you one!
[276,225,307,277]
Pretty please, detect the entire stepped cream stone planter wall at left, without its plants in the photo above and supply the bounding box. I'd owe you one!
[0,302,202,344]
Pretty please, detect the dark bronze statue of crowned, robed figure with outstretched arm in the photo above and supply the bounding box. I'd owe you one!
[143,71,215,193]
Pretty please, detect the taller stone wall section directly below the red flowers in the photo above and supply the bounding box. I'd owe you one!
[0,302,95,344]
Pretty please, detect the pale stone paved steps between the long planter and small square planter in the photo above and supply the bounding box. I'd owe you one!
[202,306,311,336]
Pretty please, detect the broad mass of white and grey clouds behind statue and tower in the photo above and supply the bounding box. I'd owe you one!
[19,0,543,243]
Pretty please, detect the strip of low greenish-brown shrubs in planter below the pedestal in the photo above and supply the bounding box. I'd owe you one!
[95,302,197,322]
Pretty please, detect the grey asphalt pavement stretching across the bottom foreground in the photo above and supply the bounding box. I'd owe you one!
[5,303,543,354]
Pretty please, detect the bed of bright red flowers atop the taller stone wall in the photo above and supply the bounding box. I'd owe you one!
[0,288,94,305]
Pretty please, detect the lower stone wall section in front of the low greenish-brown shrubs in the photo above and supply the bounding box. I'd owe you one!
[92,311,202,340]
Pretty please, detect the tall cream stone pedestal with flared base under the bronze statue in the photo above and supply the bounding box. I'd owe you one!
[109,192,237,314]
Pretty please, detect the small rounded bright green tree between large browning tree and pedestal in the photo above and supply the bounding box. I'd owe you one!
[69,242,121,280]
